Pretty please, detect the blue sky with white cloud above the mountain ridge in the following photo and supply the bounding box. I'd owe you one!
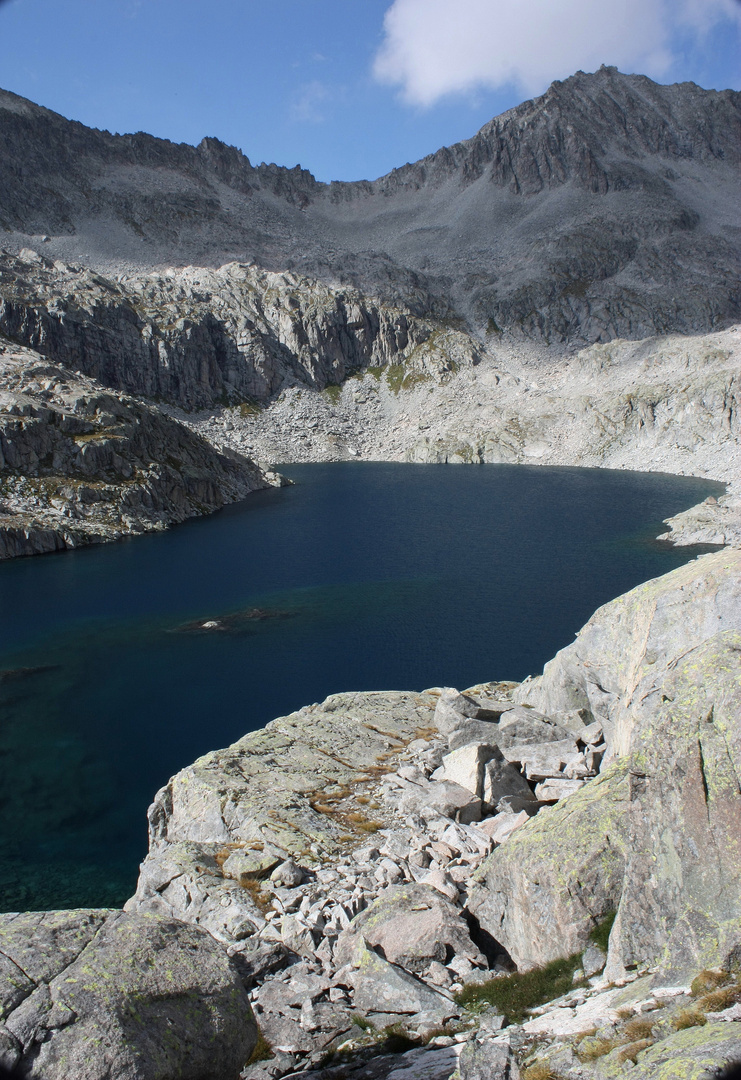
[0,0,741,180]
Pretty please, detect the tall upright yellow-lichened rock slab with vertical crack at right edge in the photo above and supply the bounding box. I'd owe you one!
[604,631,741,983]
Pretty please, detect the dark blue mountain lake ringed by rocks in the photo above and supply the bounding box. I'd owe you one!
[0,463,722,910]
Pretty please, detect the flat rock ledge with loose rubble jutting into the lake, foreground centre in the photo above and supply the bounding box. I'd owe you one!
[126,684,604,1072]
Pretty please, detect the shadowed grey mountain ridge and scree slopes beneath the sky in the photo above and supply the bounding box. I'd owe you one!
[0,68,741,343]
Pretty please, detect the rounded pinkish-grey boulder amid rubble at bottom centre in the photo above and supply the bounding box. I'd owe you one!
[335,885,487,974]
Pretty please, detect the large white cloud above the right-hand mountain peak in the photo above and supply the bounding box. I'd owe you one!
[374,0,741,106]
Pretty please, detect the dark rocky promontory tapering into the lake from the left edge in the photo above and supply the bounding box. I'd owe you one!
[0,341,281,558]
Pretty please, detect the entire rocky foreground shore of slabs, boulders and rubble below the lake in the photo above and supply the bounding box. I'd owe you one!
[0,551,741,1080]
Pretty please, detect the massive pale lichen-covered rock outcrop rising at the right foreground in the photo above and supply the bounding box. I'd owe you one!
[470,552,741,982]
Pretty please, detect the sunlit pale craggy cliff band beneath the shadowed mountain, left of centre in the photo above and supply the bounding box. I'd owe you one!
[0,249,477,415]
